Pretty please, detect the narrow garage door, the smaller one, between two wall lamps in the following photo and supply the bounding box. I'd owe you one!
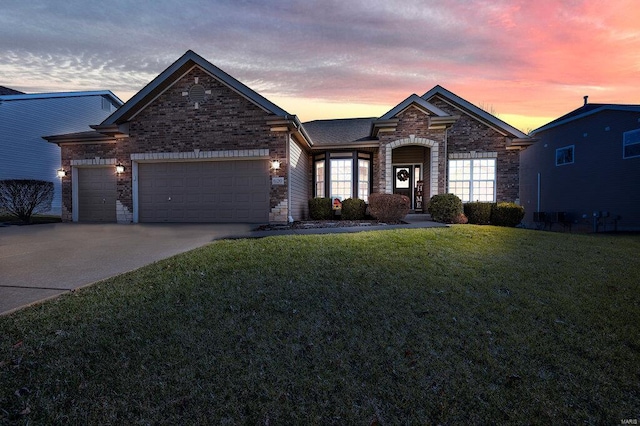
[78,167,116,222]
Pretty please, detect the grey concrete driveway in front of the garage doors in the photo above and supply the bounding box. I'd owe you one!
[0,223,252,314]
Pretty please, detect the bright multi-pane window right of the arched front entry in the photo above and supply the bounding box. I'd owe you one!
[449,158,496,203]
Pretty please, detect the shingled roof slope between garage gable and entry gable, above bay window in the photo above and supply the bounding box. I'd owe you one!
[302,117,377,146]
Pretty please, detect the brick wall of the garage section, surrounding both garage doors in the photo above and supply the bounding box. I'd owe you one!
[62,67,288,221]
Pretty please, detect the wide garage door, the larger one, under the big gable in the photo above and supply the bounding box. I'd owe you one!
[138,160,270,223]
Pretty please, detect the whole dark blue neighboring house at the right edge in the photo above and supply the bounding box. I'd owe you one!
[520,98,640,230]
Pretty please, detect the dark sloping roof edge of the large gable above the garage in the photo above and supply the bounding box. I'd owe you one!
[99,50,290,127]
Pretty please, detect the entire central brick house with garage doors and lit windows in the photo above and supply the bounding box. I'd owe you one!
[46,51,531,223]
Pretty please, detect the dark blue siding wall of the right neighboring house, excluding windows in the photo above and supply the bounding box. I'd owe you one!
[520,111,640,230]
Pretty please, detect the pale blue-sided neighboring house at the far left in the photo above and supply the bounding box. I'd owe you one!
[0,91,122,215]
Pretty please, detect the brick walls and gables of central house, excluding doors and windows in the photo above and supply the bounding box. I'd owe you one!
[52,51,527,222]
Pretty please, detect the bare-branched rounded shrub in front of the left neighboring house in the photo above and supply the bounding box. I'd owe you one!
[0,179,53,223]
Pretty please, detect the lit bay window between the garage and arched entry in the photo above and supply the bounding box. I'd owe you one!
[314,151,371,202]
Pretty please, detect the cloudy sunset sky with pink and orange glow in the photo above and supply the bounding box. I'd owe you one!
[0,0,640,132]
